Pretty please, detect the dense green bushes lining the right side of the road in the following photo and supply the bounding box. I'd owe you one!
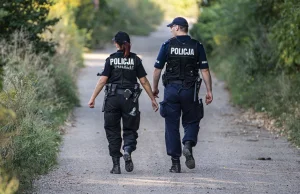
[191,0,300,144]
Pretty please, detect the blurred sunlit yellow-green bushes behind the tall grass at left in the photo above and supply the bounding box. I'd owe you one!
[44,0,85,105]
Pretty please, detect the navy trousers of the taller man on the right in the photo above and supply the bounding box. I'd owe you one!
[160,83,203,158]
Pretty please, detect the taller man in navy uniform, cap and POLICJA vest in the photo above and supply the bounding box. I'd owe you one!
[153,17,213,173]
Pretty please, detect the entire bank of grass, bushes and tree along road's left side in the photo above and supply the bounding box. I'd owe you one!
[0,0,84,192]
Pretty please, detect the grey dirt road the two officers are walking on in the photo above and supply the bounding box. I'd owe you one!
[35,22,300,194]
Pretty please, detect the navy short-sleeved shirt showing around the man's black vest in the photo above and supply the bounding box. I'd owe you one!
[154,35,208,69]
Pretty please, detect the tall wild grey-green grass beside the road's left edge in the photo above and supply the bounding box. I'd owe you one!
[0,34,81,192]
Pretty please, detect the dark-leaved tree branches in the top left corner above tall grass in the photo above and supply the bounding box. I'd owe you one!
[0,0,58,54]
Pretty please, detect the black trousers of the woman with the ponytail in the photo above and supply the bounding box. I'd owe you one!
[104,94,140,157]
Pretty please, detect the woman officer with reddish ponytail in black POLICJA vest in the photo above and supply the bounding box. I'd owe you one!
[89,31,158,174]
